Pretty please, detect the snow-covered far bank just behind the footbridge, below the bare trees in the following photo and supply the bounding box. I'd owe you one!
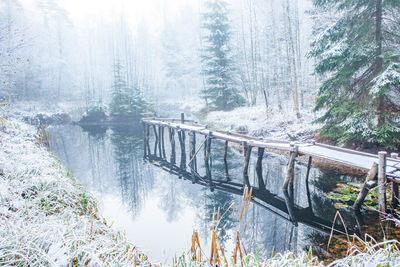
[158,96,321,141]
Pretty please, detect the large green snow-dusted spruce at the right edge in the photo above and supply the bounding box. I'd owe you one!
[310,0,400,148]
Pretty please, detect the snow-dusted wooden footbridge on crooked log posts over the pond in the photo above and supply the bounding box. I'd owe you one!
[142,113,400,213]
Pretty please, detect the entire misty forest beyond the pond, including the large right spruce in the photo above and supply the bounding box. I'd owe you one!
[1,0,400,149]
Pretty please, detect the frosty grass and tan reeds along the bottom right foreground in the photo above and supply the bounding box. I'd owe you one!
[174,187,400,267]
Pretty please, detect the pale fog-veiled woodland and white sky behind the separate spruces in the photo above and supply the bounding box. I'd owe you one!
[0,0,317,117]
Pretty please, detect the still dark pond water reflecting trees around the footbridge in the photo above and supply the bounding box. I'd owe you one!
[49,125,398,264]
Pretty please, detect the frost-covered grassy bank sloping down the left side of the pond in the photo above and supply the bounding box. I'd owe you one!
[0,120,149,266]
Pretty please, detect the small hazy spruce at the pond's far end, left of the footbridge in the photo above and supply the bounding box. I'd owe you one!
[110,59,147,119]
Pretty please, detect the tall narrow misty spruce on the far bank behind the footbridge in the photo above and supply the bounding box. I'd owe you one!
[201,0,245,110]
